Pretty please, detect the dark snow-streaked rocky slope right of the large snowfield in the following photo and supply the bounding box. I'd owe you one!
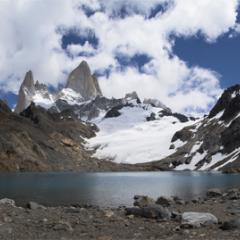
[145,85,240,172]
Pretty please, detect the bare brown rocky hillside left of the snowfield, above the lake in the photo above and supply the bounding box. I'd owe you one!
[0,103,109,171]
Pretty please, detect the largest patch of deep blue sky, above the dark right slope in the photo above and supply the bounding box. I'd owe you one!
[174,36,240,88]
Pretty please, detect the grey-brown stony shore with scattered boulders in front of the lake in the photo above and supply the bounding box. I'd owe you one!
[0,189,240,240]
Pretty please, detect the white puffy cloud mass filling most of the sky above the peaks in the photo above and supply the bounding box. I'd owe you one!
[0,0,239,113]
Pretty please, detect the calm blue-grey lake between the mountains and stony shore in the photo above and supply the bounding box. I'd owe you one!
[0,171,240,207]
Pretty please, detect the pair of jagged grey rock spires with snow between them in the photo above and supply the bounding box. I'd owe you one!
[15,61,102,113]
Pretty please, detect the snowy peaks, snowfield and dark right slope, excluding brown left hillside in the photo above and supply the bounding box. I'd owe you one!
[12,62,240,172]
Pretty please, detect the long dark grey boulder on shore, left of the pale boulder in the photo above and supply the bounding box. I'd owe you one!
[126,204,171,220]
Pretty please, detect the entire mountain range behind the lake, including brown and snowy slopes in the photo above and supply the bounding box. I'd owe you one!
[0,61,240,172]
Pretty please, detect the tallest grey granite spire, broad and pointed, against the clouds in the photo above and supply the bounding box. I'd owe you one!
[66,61,102,100]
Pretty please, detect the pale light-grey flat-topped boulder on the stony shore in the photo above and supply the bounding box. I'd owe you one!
[182,212,218,227]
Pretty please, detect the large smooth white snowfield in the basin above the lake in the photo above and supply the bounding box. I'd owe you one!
[87,106,193,164]
